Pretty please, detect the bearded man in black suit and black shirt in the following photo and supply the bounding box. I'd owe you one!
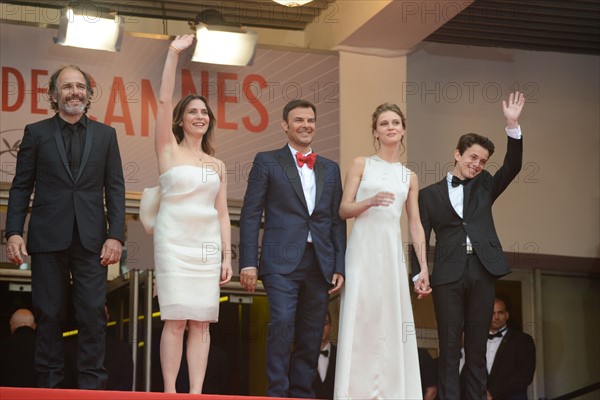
[6,65,125,389]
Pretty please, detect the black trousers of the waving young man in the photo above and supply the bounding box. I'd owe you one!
[432,254,496,400]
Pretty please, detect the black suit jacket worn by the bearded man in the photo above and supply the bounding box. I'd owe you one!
[6,114,125,253]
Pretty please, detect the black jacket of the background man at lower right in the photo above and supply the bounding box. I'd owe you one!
[487,329,535,400]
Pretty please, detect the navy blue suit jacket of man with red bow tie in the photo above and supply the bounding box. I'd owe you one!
[240,144,346,282]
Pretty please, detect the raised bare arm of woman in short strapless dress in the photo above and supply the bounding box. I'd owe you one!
[154,35,194,166]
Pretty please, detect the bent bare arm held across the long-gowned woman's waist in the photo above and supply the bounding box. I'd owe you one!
[340,157,394,219]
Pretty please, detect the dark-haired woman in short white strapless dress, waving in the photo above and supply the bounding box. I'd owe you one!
[154,35,232,393]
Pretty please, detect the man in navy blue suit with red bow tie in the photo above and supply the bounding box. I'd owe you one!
[240,100,346,398]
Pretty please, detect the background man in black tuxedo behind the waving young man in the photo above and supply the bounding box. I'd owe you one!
[486,297,535,400]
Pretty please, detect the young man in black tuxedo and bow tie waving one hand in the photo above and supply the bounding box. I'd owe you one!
[413,92,525,400]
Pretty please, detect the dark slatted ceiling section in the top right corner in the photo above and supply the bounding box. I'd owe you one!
[425,0,600,55]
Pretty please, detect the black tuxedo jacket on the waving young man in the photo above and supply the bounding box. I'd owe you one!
[412,137,523,286]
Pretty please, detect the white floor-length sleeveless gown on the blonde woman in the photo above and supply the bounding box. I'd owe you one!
[334,156,422,400]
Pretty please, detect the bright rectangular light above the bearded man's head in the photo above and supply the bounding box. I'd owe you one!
[54,8,125,51]
